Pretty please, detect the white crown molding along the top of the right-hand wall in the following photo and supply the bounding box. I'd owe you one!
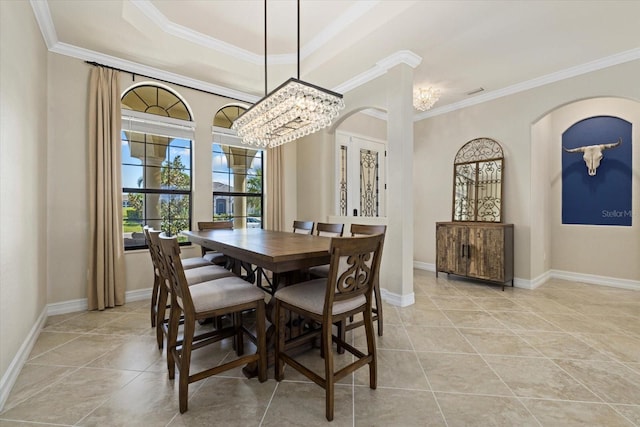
[413,48,640,122]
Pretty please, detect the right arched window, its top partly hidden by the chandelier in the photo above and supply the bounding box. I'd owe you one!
[212,105,264,228]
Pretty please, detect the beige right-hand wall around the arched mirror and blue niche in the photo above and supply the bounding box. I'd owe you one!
[414,57,640,286]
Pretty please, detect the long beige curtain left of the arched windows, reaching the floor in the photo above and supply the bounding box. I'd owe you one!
[87,67,125,310]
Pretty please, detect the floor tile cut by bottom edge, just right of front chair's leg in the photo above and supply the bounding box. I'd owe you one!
[353,387,446,427]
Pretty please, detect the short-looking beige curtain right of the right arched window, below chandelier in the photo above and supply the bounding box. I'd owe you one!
[266,145,284,231]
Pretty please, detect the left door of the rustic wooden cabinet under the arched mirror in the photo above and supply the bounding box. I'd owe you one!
[436,224,467,276]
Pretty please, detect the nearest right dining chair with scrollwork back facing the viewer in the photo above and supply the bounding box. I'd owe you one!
[274,234,384,421]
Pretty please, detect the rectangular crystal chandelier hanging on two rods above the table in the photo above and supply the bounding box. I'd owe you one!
[231,0,344,147]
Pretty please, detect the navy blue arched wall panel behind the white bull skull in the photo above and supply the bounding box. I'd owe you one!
[561,116,633,226]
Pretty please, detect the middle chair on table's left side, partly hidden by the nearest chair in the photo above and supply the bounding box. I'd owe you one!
[145,229,235,349]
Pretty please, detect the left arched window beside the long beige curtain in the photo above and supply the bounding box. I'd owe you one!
[122,84,194,249]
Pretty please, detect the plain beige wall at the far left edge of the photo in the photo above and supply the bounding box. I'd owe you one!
[0,1,47,388]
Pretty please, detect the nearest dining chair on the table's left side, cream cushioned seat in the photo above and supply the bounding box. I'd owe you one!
[160,235,267,413]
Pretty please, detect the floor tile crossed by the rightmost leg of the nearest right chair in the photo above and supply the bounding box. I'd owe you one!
[355,349,429,390]
